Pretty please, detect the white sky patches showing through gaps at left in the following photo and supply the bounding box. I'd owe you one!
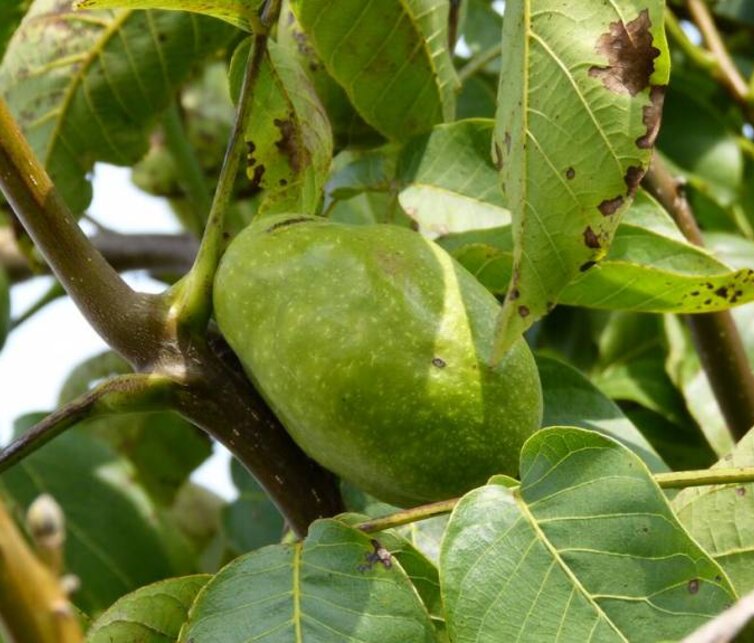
[0,164,237,499]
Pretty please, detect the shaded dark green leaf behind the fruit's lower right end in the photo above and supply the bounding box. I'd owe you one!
[536,355,668,472]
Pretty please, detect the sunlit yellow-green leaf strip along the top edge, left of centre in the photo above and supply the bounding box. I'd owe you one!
[74,0,264,31]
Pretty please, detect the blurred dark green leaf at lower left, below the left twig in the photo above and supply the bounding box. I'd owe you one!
[0,417,192,614]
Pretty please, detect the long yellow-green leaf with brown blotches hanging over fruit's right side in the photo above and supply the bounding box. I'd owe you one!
[494,0,669,355]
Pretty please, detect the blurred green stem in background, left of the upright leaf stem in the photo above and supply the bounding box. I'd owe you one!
[162,98,212,235]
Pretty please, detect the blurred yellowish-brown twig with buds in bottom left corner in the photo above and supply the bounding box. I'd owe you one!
[0,504,84,643]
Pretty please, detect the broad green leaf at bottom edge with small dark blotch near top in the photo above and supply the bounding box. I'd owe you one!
[179,520,435,643]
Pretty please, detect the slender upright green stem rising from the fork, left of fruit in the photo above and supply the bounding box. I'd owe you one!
[174,33,267,333]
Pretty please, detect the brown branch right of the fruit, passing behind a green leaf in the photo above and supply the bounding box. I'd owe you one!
[644,154,754,441]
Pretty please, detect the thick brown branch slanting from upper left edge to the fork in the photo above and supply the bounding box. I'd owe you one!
[0,99,164,366]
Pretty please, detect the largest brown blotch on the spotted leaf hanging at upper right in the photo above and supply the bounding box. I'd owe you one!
[589,9,660,96]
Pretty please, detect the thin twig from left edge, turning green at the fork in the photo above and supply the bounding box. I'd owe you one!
[0,375,172,473]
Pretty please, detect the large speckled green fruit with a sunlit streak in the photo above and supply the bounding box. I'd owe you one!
[214,215,542,506]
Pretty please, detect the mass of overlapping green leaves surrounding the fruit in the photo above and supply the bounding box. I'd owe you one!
[0,0,754,643]
